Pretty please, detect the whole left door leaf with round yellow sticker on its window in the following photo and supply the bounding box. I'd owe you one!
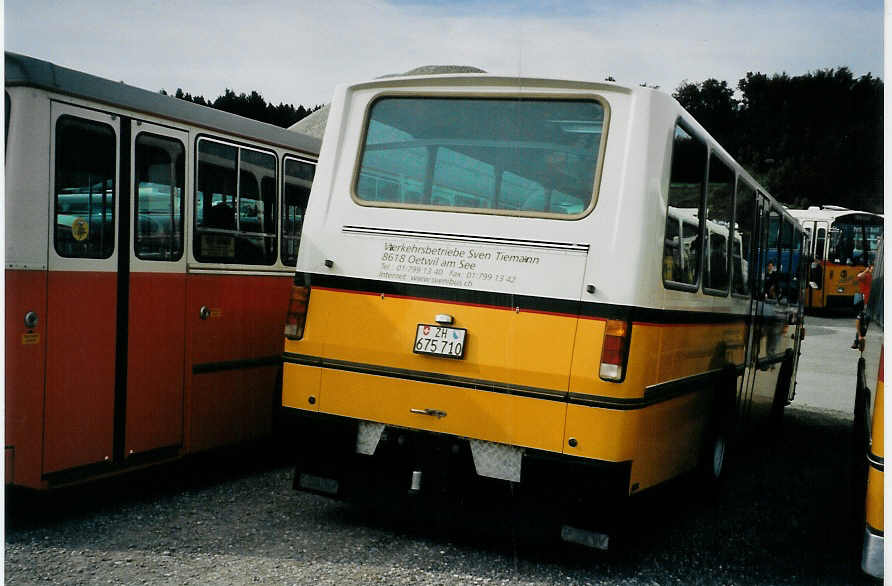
[43,102,120,474]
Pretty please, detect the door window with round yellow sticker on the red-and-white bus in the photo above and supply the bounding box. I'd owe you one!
[54,116,117,258]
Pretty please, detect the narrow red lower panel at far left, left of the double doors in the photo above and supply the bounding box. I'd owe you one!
[5,270,47,488]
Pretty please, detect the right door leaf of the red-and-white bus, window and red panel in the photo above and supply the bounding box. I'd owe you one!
[121,121,189,458]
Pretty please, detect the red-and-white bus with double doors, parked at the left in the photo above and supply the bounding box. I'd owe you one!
[5,53,319,489]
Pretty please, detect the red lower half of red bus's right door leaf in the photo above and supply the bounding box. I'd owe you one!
[124,273,186,455]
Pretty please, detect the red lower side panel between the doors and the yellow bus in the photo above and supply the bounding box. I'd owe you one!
[186,275,292,451]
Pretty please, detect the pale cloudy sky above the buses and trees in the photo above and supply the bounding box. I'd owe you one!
[4,0,884,104]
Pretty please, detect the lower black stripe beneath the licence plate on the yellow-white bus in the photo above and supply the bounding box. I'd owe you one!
[282,352,732,410]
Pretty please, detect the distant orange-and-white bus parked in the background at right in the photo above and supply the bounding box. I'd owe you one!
[788,205,883,310]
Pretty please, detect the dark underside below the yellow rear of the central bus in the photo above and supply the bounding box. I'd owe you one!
[283,408,631,510]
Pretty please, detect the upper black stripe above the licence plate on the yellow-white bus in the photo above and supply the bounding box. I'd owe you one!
[294,273,760,324]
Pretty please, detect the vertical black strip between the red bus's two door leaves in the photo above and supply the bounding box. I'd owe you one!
[112,116,132,462]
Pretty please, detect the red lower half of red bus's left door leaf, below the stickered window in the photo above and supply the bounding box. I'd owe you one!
[43,271,117,474]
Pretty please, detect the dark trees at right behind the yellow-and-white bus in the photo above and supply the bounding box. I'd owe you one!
[672,67,883,212]
